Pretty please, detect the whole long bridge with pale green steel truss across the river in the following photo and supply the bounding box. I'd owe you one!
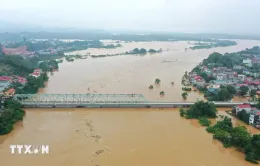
[12,94,256,108]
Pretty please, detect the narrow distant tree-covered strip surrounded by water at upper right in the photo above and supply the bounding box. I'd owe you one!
[190,40,237,50]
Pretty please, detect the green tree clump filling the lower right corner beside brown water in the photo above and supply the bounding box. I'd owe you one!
[207,117,260,164]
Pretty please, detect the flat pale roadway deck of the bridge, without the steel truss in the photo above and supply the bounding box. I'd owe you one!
[20,102,256,108]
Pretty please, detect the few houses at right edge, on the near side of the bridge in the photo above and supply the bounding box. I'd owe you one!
[234,104,260,129]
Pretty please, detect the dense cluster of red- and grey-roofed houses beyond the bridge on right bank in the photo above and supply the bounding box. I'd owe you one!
[189,57,260,96]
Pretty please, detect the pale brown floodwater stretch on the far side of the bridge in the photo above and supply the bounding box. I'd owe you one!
[42,40,260,101]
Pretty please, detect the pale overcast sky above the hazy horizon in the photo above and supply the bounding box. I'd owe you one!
[0,0,260,34]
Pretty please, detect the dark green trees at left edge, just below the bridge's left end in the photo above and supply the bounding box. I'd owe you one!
[0,100,25,135]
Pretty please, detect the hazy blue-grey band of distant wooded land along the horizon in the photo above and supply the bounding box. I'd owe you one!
[0,30,260,42]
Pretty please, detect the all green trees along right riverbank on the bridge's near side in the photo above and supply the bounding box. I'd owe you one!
[180,101,260,164]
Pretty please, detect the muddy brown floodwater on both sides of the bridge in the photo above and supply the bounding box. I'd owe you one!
[0,40,260,166]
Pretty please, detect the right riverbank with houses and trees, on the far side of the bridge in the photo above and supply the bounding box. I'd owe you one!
[182,46,260,101]
